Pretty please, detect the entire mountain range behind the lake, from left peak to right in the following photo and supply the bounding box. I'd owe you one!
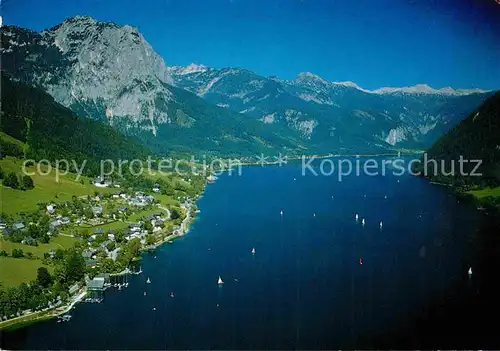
[1,16,492,156]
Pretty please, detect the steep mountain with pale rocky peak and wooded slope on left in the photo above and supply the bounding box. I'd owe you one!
[1,16,305,156]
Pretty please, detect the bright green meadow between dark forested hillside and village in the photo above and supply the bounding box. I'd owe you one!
[0,157,115,214]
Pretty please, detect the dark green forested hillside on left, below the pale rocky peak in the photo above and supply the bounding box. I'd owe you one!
[0,73,150,173]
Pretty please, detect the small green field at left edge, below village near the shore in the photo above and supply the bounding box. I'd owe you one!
[0,257,53,287]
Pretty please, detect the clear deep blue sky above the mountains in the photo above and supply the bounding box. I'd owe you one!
[2,0,500,89]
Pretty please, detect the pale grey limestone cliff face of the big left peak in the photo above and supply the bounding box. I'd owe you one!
[4,16,172,134]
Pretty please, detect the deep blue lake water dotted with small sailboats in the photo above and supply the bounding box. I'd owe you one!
[2,159,486,349]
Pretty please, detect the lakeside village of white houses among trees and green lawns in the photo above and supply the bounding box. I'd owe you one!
[0,173,205,323]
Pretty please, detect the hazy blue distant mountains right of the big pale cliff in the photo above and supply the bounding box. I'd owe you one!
[169,64,491,148]
